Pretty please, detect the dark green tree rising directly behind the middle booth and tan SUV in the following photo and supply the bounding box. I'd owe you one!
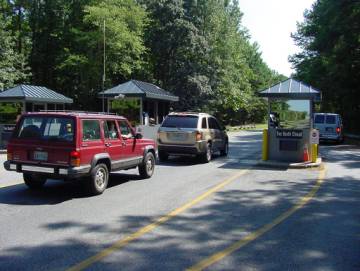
[144,0,210,110]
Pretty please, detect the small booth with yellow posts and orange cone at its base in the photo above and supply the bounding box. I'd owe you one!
[260,78,321,163]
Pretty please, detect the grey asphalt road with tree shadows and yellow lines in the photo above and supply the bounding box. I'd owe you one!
[0,132,360,270]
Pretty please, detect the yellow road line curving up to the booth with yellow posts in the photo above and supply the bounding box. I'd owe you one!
[187,168,325,271]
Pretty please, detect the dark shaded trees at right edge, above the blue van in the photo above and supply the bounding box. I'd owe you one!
[290,0,360,131]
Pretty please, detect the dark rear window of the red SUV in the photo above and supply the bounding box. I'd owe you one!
[14,116,74,142]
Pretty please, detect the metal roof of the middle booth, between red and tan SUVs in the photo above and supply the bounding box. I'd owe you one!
[99,80,179,102]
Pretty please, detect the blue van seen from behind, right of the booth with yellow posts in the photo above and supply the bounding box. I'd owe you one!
[314,113,344,142]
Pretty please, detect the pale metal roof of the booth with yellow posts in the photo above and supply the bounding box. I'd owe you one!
[259,78,320,99]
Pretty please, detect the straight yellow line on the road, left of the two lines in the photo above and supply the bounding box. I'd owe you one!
[68,169,249,271]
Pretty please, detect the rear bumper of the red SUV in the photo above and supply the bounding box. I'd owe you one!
[4,161,91,178]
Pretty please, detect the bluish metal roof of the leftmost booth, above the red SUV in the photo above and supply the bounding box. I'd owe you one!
[0,85,73,104]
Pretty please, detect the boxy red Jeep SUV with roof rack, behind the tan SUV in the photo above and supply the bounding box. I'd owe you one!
[4,112,155,194]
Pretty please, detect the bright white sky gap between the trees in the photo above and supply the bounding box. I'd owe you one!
[239,0,315,77]
